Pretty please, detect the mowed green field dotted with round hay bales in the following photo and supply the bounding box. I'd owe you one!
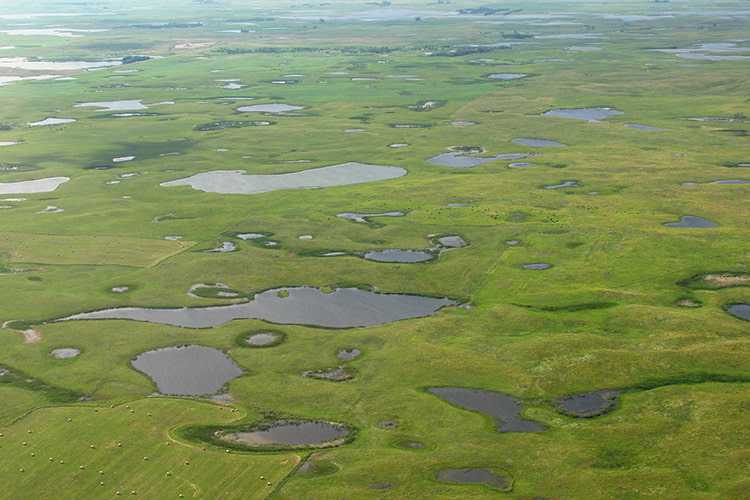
[0,399,299,500]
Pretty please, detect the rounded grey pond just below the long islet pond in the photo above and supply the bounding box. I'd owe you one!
[131,345,242,396]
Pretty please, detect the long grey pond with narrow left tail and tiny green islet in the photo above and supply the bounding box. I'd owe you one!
[59,287,456,328]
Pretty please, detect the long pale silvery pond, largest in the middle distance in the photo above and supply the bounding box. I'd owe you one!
[160,162,406,194]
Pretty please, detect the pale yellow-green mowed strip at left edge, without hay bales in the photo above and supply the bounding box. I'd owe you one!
[0,232,192,267]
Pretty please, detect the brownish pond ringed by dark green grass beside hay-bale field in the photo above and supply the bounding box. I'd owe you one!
[227,419,349,446]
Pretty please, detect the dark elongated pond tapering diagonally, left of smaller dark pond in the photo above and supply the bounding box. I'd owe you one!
[427,387,546,432]
